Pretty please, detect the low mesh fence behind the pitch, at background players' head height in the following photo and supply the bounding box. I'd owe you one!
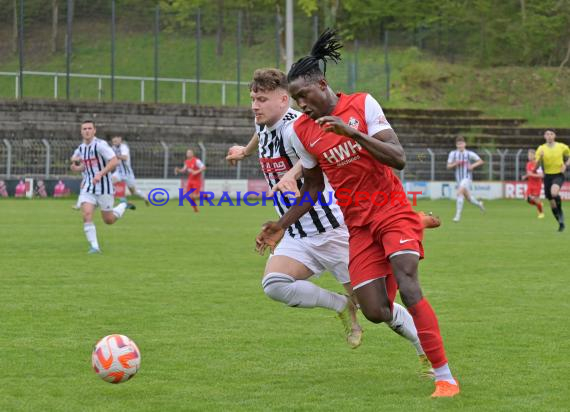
[0,139,527,181]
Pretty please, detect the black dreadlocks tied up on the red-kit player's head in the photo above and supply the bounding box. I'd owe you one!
[287,29,342,82]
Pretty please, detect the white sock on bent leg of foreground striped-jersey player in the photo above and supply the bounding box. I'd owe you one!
[261,272,348,312]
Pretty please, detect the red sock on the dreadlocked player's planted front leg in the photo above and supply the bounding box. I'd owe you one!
[408,298,447,368]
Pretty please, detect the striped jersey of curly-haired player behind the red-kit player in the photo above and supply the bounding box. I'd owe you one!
[256,109,344,238]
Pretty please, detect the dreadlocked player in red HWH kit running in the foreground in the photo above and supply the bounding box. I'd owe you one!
[256,30,459,397]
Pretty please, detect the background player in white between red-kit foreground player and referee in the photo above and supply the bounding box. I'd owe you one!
[447,136,485,222]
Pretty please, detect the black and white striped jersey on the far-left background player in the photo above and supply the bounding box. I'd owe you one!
[74,137,115,195]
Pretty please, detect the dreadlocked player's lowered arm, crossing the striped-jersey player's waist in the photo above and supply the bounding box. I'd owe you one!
[255,166,325,255]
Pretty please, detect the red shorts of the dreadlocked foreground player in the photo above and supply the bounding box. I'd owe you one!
[348,209,424,290]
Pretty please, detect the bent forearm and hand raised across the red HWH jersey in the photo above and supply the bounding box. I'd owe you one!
[317,116,406,170]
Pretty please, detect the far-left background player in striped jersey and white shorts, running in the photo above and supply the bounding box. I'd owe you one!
[71,120,131,253]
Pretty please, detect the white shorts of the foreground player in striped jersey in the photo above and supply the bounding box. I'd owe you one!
[269,225,350,283]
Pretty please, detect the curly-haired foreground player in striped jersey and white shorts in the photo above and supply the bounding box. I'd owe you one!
[227,69,424,355]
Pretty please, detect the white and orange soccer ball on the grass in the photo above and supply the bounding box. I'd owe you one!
[91,335,141,383]
